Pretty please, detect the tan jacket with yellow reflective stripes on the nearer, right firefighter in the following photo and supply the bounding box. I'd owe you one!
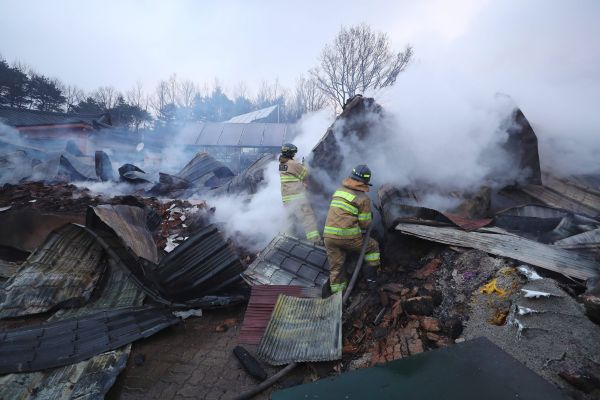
[323,178,373,239]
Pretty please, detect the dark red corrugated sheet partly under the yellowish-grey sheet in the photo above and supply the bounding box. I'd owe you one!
[238,285,321,344]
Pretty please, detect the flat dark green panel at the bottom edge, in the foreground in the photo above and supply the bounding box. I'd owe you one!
[272,338,566,400]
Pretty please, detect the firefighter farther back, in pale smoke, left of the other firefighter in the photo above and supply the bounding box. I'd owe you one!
[279,143,323,244]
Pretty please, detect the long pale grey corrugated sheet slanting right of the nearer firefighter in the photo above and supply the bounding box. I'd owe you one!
[396,224,600,279]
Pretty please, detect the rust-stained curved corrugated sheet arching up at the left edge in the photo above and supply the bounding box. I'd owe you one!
[0,225,106,318]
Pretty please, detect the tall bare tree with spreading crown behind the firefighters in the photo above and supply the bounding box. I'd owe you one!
[310,24,413,107]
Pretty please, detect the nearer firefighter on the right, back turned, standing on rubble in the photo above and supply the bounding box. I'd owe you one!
[323,165,380,293]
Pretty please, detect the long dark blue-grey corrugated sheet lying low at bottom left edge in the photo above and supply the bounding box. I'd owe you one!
[0,306,179,374]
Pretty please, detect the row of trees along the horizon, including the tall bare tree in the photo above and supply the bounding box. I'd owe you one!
[0,24,413,130]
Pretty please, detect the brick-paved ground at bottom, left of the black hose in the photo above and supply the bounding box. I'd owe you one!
[106,307,276,400]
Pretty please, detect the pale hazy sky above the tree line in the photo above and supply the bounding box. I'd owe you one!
[0,0,488,90]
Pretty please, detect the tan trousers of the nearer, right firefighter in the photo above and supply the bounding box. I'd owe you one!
[325,237,380,293]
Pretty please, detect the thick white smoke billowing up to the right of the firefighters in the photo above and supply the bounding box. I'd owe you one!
[312,1,600,210]
